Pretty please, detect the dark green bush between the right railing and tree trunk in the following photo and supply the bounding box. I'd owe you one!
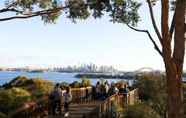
[134,74,167,117]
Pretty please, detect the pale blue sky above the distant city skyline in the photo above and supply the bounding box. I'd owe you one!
[0,2,181,70]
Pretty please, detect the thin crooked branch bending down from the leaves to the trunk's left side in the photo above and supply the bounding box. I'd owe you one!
[127,24,163,57]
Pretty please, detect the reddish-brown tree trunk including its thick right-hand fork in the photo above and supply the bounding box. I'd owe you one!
[164,0,186,118]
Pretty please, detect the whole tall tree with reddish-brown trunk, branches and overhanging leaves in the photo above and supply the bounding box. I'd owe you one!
[0,0,186,118]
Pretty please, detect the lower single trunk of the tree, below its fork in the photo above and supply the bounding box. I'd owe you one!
[166,67,183,118]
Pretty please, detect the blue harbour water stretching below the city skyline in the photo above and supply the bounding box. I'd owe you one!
[0,71,133,85]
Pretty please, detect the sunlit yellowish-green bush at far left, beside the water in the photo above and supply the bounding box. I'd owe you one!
[0,76,53,118]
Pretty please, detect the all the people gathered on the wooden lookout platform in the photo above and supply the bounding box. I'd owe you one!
[49,81,129,117]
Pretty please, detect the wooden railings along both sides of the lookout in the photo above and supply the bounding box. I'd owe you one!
[10,87,138,118]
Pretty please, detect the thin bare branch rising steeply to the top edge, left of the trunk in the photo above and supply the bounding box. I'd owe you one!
[147,0,162,45]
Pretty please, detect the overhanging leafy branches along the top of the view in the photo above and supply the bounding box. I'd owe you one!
[0,0,141,25]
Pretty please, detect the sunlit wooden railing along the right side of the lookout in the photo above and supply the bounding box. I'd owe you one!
[85,89,138,118]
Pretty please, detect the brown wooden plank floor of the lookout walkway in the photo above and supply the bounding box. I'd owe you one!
[45,101,100,118]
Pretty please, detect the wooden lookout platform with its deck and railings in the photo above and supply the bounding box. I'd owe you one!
[11,87,138,118]
